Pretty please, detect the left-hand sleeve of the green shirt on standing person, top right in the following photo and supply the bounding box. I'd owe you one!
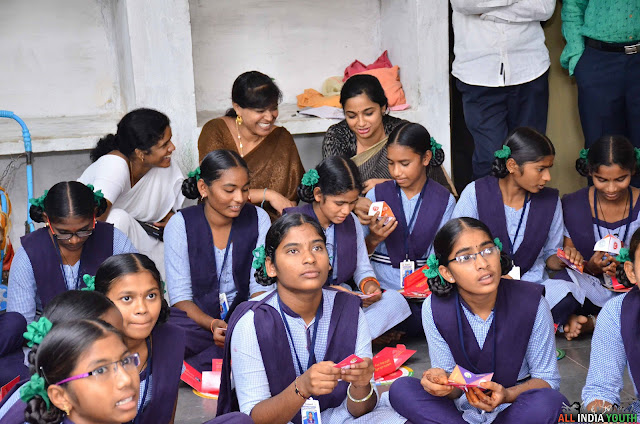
[560,0,589,75]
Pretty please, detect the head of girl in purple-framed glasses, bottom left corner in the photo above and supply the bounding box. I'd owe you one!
[20,320,140,424]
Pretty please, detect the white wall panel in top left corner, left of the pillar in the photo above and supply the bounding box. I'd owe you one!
[0,0,121,117]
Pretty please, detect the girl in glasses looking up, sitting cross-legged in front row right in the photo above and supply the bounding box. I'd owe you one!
[389,218,568,424]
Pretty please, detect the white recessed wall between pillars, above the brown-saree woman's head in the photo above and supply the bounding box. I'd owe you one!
[189,0,384,111]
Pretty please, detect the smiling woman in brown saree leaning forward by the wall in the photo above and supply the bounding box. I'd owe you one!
[198,71,304,220]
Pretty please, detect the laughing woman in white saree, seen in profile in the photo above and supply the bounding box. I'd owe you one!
[78,109,184,275]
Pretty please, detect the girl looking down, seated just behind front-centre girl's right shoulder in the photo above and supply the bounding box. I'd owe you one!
[285,156,411,339]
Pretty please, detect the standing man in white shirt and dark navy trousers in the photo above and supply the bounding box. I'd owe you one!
[451,0,556,178]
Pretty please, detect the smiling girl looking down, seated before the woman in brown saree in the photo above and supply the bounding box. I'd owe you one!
[164,150,271,371]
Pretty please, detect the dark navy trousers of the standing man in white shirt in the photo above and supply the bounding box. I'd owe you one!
[456,71,549,179]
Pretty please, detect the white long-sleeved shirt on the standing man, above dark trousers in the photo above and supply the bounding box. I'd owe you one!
[451,0,556,87]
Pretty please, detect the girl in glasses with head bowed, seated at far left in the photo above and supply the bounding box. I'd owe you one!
[7,181,136,323]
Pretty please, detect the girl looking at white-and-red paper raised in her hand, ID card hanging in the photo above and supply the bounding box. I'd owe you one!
[360,122,456,337]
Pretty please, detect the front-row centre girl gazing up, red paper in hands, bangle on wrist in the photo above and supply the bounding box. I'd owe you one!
[218,213,406,424]
